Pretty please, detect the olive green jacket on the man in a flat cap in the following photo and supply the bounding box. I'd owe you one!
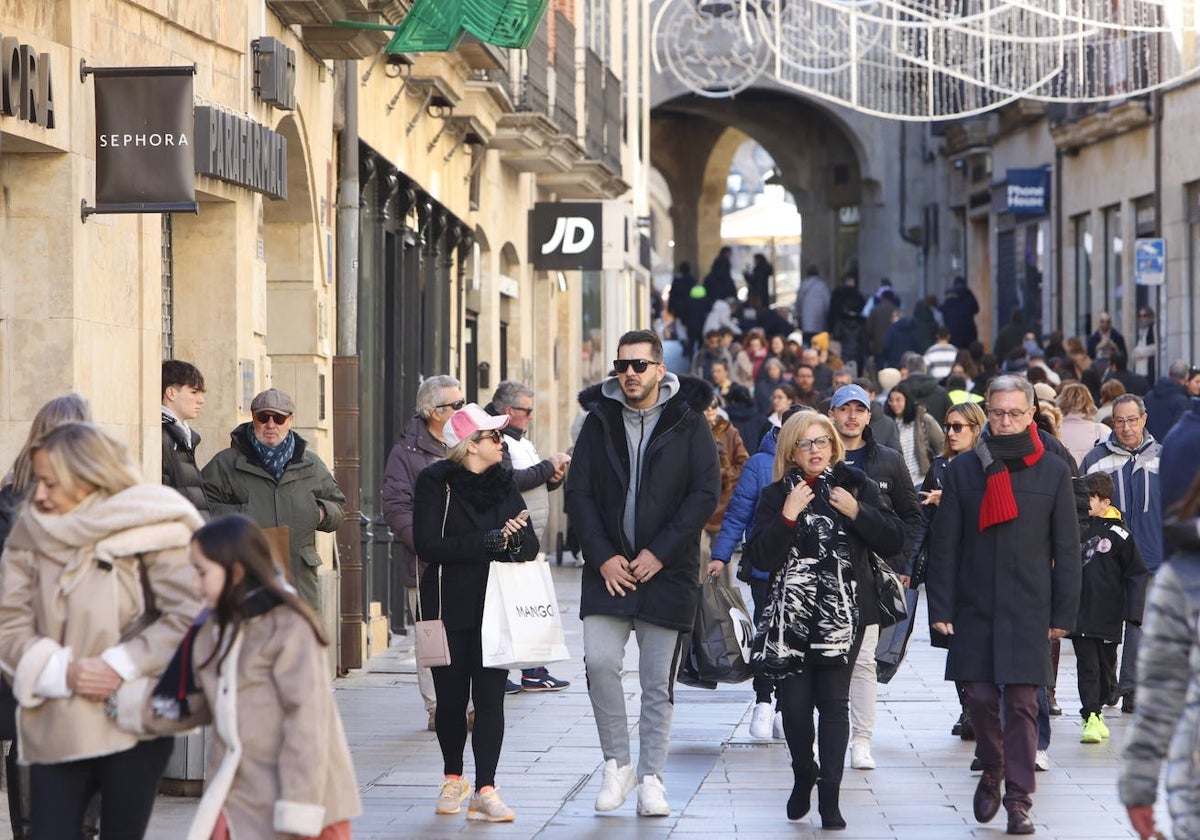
[200,422,346,581]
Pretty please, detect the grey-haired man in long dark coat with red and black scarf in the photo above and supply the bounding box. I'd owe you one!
[925,376,1082,834]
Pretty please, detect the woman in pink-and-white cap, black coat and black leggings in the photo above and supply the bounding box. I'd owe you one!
[413,403,538,822]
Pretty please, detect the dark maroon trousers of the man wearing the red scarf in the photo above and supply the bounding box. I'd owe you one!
[965,683,1038,810]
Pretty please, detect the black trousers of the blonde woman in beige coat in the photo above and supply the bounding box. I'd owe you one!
[30,738,175,840]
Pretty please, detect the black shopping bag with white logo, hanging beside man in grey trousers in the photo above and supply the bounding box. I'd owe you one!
[691,577,754,683]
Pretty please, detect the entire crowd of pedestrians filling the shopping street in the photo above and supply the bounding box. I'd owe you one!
[0,258,1200,840]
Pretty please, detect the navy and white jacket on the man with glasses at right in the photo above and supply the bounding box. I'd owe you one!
[1079,432,1163,572]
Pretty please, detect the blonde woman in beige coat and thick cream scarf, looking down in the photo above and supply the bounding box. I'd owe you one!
[0,422,202,838]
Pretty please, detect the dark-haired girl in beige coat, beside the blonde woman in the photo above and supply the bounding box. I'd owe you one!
[140,515,361,840]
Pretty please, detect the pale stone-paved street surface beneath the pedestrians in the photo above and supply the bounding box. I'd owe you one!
[129,569,1162,840]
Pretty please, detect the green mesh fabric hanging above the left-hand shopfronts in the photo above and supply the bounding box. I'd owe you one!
[335,0,550,53]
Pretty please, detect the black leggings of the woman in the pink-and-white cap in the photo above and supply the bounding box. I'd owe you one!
[433,630,509,790]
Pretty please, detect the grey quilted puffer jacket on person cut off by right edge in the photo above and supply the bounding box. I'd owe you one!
[1118,518,1200,840]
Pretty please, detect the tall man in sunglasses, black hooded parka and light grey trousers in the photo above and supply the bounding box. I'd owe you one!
[566,330,721,816]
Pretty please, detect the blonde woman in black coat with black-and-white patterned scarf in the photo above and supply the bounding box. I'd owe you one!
[745,412,904,828]
